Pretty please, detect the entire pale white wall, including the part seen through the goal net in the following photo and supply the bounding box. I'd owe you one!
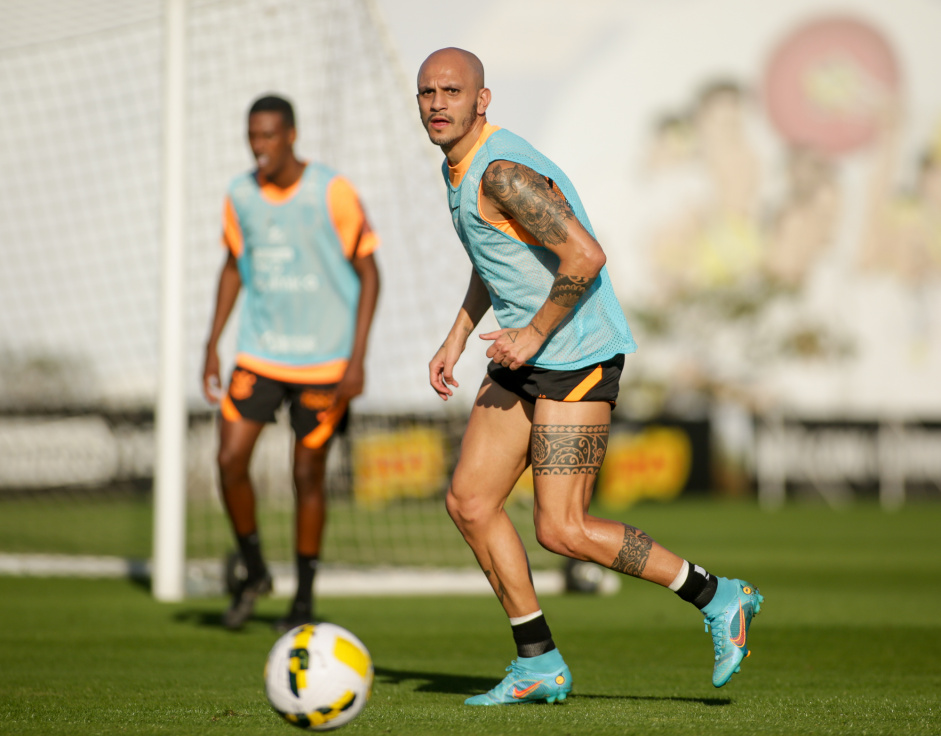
[0,0,941,417]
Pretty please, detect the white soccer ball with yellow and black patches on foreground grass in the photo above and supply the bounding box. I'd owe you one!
[265,624,373,731]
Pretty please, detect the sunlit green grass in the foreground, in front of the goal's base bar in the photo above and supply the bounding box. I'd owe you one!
[0,503,941,736]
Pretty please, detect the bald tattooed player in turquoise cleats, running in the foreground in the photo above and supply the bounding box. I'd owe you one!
[417,48,762,705]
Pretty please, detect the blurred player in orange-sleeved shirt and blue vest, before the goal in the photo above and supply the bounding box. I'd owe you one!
[203,96,379,631]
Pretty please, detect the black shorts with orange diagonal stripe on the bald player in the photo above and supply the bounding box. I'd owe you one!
[487,354,624,407]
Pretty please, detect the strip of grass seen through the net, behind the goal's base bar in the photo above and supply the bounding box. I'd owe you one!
[0,494,558,569]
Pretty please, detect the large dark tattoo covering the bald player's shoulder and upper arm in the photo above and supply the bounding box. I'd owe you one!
[481,161,575,245]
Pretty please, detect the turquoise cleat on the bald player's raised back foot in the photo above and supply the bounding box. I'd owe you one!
[702,578,764,687]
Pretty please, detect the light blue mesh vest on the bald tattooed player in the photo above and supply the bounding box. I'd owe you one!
[442,128,637,370]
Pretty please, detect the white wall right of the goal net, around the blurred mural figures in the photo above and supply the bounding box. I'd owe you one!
[377,0,941,416]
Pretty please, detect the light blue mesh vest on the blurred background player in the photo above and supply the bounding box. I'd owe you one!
[229,162,360,366]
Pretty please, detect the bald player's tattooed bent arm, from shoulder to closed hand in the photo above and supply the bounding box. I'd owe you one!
[480,161,605,369]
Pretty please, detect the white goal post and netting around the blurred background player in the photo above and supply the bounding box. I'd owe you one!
[0,0,500,600]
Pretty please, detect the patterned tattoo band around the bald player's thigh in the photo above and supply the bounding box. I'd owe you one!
[532,424,608,475]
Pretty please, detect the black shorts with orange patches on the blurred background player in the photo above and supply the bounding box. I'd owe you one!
[222,366,349,448]
